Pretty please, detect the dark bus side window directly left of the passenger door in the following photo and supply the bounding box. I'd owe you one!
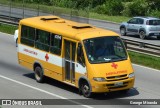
[50,34,62,55]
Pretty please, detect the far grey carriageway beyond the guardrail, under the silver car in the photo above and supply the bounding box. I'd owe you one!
[0,5,160,45]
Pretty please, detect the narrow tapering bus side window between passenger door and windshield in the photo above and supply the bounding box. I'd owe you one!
[77,43,85,67]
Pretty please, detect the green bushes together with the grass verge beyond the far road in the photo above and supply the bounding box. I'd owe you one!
[0,0,160,23]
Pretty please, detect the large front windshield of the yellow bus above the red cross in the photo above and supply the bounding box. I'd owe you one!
[84,36,127,63]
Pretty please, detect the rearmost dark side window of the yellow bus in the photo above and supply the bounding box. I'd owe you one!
[21,25,35,47]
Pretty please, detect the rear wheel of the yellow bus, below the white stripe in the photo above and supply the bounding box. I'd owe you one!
[34,66,44,83]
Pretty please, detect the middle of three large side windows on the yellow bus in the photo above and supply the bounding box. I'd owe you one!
[35,30,50,52]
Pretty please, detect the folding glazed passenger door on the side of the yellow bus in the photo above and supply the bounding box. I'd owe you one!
[64,40,76,83]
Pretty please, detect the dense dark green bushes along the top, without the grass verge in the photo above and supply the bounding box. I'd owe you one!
[7,0,160,17]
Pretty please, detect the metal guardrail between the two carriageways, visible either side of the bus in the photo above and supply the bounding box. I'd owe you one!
[0,15,160,57]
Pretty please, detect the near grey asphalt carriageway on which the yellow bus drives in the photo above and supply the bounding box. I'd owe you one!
[0,33,160,108]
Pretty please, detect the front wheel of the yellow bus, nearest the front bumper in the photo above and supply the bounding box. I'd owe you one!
[81,82,92,98]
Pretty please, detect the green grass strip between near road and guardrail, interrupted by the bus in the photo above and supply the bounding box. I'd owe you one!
[0,24,160,70]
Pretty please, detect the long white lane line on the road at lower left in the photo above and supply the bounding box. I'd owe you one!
[0,75,93,108]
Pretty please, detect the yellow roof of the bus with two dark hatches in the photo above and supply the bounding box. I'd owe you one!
[20,16,118,40]
